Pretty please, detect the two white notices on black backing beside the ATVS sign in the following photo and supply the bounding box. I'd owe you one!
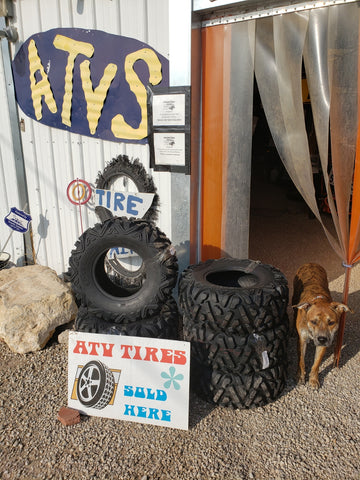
[149,87,190,174]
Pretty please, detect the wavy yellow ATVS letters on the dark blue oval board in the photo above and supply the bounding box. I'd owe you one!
[28,34,162,140]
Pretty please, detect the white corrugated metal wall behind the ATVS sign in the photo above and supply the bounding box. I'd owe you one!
[0,0,176,274]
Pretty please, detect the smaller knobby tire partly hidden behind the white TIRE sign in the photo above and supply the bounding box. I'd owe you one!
[95,155,159,222]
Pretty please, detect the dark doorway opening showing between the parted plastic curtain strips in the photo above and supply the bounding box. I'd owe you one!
[249,80,343,290]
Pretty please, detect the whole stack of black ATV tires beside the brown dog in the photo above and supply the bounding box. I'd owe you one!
[179,258,289,408]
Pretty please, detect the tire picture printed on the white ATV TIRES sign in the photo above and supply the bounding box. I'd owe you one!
[76,360,115,410]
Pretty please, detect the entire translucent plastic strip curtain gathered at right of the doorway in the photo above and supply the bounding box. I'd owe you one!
[255,4,360,363]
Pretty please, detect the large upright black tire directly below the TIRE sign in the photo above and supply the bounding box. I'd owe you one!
[66,217,178,323]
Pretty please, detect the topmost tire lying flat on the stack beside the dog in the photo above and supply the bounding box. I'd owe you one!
[179,258,289,336]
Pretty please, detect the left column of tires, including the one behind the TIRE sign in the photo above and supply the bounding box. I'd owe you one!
[66,155,179,339]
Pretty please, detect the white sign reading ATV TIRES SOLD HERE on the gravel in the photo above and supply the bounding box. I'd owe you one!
[68,332,190,430]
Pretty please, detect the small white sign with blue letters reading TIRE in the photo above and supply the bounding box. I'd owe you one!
[94,188,155,218]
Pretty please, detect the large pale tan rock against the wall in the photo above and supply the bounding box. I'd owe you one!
[0,265,77,353]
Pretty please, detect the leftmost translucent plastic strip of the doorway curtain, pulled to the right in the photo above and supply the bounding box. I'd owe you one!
[255,12,342,256]
